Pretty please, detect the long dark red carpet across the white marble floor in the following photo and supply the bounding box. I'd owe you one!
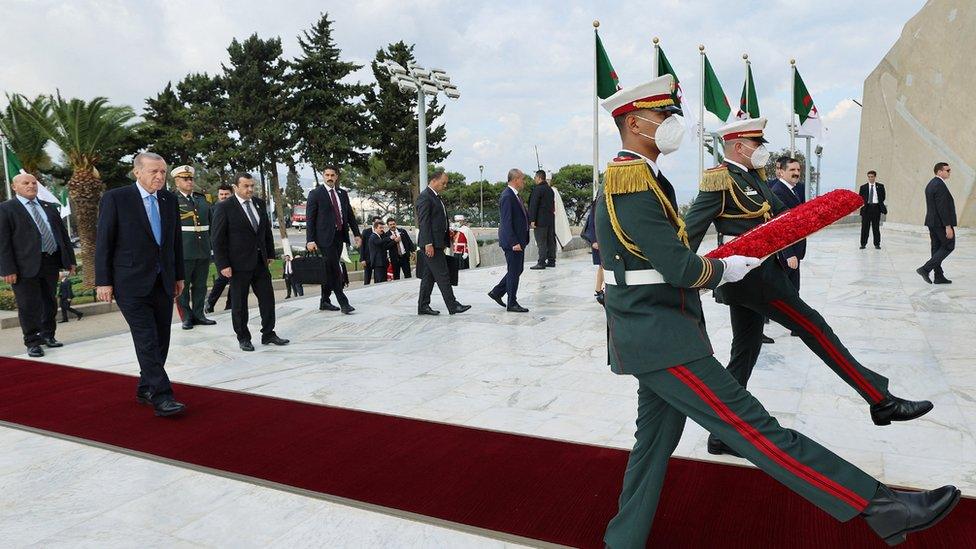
[0,358,976,549]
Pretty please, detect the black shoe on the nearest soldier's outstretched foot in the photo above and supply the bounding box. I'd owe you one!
[861,484,962,545]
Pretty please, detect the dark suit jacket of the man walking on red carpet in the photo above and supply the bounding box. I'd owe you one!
[95,183,184,297]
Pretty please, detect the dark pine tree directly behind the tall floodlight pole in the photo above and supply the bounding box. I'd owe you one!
[366,41,451,204]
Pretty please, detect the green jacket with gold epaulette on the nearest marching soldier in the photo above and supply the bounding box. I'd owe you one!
[596,152,725,374]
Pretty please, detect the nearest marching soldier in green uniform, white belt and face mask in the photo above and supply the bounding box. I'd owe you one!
[596,75,960,549]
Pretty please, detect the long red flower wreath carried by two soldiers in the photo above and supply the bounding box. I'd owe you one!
[705,189,864,259]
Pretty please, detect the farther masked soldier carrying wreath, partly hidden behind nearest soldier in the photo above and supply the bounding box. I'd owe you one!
[685,118,932,455]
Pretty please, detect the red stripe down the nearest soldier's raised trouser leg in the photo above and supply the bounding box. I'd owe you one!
[668,366,868,511]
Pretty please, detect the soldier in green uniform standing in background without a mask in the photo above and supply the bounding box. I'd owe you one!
[170,166,217,330]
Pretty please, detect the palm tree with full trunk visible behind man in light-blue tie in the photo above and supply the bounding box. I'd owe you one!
[14,92,138,287]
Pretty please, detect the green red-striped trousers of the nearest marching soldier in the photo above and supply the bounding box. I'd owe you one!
[603,356,879,549]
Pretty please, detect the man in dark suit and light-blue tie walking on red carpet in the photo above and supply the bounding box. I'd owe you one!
[95,152,185,416]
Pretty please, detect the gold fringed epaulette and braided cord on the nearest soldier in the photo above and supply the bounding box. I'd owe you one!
[603,159,688,261]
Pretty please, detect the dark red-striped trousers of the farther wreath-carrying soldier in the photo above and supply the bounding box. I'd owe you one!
[716,258,889,404]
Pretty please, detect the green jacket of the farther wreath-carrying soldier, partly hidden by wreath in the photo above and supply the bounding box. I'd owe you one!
[684,163,789,303]
